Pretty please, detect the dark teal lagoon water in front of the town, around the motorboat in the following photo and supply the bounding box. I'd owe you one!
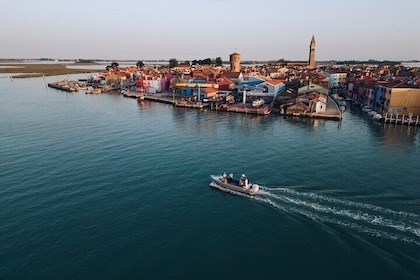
[0,73,420,279]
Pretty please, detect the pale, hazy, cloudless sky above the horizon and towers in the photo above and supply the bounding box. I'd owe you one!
[0,0,420,61]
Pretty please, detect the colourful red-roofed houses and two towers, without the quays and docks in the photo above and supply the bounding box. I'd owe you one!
[92,36,420,121]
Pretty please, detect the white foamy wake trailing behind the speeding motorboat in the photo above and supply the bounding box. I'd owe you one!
[220,187,420,246]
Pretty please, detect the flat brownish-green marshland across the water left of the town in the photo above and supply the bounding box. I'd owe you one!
[0,63,99,79]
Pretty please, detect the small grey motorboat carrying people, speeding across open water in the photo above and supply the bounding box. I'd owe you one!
[210,173,260,195]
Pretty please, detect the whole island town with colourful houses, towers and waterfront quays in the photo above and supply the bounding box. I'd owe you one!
[44,36,420,125]
